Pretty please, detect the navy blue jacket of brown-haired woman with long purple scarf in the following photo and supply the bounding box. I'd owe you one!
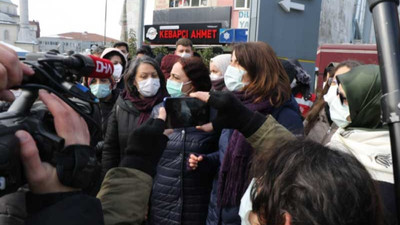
[206,97,304,225]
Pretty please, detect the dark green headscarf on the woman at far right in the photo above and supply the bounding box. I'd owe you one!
[337,65,382,129]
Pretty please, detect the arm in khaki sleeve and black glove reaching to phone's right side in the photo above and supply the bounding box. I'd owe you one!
[190,91,295,153]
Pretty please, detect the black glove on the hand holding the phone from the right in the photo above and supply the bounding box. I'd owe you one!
[208,91,266,137]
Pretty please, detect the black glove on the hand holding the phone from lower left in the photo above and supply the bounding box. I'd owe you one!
[120,119,168,176]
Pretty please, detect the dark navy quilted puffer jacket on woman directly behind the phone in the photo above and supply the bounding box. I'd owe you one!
[149,128,219,225]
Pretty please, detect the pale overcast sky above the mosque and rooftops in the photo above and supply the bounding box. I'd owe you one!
[11,0,124,39]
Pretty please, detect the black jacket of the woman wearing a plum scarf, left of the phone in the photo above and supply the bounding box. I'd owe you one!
[102,96,144,176]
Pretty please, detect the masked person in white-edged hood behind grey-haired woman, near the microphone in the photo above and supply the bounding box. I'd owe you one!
[101,48,127,90]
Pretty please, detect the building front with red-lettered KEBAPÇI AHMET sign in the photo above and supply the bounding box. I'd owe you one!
[138,0,251,46]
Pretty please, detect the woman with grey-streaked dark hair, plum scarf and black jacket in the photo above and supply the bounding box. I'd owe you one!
[102,56,167,178]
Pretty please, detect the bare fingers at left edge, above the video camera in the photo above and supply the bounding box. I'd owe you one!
[0,44,34,101]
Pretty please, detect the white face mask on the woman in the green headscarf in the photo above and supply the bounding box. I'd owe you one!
[328,96,350,128]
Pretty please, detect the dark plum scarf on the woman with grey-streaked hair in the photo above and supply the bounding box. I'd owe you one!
[122,88,167,125]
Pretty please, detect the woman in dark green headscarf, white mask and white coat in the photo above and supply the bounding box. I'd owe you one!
[327,65,396,223]
